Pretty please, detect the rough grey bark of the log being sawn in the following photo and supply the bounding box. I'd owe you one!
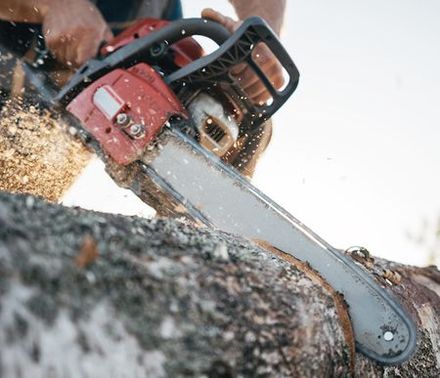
[0,193,440,377]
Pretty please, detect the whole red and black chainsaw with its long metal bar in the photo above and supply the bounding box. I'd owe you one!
[16,17,417,364]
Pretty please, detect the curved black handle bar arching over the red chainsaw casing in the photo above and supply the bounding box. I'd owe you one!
[54,18,231,105]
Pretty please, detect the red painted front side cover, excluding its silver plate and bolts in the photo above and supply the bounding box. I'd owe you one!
[67,63,187,165]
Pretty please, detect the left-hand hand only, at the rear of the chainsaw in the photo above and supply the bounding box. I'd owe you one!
[43,0,113,67]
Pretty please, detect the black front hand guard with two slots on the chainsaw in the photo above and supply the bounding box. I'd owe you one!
[165,17,299,133]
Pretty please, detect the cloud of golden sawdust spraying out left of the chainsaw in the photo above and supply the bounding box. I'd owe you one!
[0,98,90,202]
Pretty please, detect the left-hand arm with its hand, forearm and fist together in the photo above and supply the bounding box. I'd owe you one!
[0,0,112,67]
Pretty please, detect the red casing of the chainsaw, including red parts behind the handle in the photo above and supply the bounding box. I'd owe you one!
[67,19,203,165]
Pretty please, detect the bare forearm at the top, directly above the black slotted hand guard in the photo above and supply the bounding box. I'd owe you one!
[229,0,286,34]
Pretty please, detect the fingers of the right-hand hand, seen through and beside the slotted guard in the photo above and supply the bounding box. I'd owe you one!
[202,8,284,105]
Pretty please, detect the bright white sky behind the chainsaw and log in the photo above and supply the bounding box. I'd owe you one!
[64,0,440,266]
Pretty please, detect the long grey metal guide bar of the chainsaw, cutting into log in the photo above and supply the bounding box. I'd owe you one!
[144,129,416,364]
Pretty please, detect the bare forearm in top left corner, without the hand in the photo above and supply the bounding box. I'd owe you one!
[0,0,55,23]
